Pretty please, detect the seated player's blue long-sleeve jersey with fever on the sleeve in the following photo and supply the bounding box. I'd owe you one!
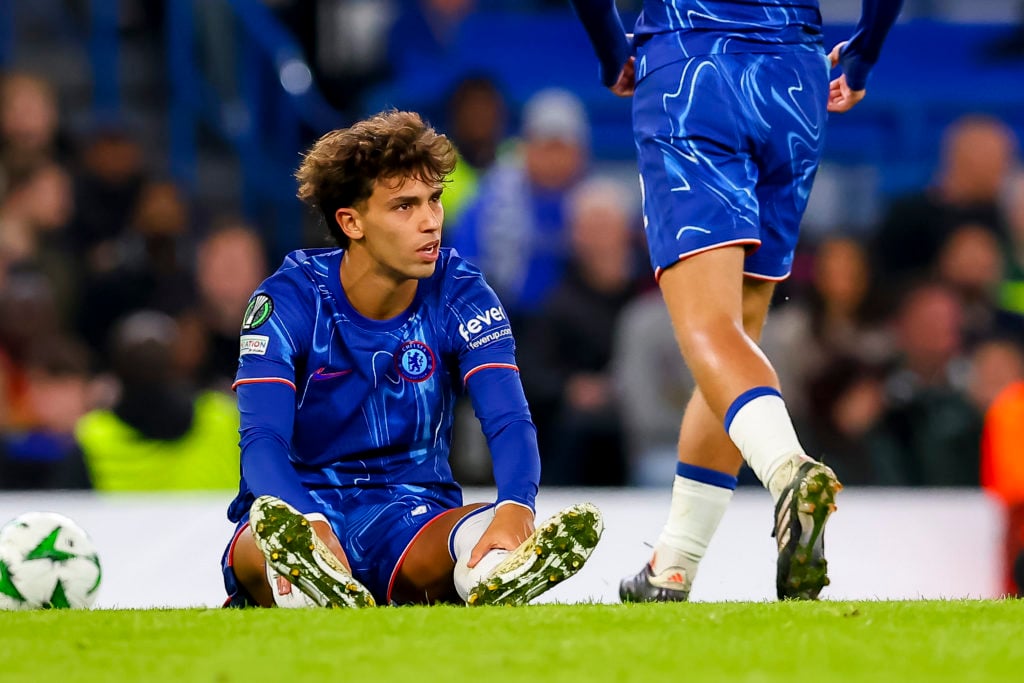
[228,249,540,521]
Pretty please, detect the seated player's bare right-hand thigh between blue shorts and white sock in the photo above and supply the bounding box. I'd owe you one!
[391,503,486,604]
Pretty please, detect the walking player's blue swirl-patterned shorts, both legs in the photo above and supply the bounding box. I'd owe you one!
[633,50,828,280]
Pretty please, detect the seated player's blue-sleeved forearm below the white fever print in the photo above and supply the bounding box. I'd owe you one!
[469,368,541,510]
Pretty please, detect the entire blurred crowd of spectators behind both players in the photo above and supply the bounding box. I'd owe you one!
[0,0,1024,540]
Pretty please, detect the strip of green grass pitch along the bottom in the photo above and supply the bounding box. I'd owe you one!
[0,600,1024,683]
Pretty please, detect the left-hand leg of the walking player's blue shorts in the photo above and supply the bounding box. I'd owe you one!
[633,55,760,271]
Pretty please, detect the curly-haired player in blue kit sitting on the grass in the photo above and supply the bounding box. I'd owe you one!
[222,112,602,607]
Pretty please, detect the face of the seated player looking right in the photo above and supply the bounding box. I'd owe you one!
[350,177,444,280]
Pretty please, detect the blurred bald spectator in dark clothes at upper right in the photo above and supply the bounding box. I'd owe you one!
[871,114,1018,283]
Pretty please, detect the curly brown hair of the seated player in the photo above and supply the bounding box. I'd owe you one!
[295,110,456,247]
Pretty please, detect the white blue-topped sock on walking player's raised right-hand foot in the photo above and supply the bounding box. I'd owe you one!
[727,392,806,500]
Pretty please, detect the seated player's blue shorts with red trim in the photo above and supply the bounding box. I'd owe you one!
[221,487,461,607]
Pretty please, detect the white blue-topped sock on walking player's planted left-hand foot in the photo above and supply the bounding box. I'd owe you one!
[651,474,733,584]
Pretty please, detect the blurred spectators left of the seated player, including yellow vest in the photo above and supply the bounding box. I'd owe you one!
[0,72,260,490]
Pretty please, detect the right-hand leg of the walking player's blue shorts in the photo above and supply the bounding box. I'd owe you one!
[743,51,828,281]
